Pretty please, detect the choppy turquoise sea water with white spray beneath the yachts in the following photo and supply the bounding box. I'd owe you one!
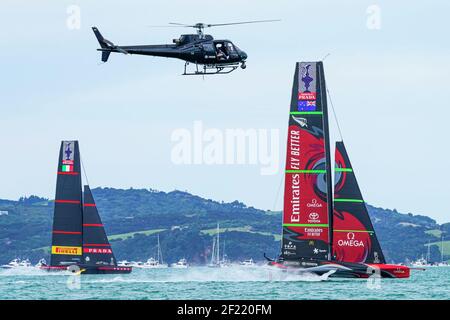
[0,266,450,300]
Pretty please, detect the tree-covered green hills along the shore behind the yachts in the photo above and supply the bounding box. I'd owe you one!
[0,188,450,263]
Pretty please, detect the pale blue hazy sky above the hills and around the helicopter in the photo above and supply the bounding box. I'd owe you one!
[0,0,450,223]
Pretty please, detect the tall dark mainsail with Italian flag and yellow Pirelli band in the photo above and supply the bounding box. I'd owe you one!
[50,141,83,266]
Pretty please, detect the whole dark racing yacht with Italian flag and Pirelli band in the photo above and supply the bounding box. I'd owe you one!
[41,141,132,274]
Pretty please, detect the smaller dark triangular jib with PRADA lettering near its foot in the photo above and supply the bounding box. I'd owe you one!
[83,186,117,266]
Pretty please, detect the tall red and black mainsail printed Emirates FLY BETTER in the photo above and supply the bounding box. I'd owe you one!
[281,62,333,260]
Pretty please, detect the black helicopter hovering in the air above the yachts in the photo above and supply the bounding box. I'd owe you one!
[92,20,279,75]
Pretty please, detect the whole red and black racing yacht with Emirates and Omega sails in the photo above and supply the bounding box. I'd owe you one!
[266,61,410,278]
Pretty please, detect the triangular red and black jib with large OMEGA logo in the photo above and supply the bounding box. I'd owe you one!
[333,142,385,263]
